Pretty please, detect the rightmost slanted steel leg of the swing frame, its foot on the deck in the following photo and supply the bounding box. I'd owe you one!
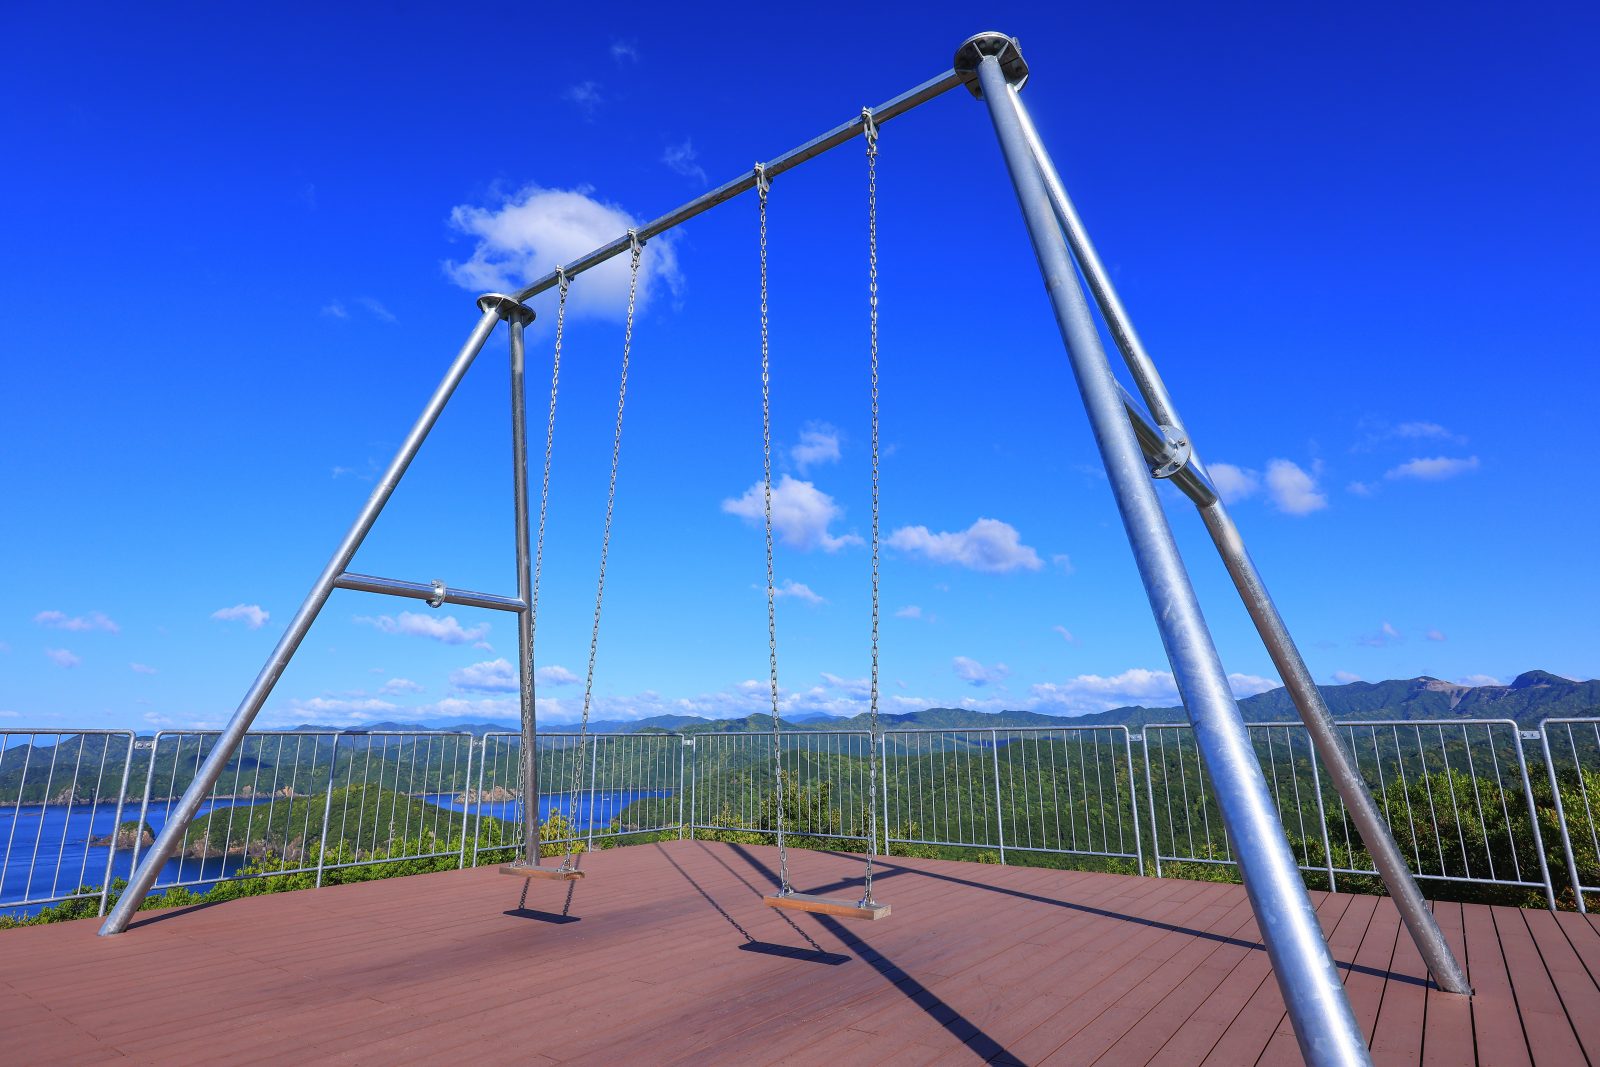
[1008,88,1472,993]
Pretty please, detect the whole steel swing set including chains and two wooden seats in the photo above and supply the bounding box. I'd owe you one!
[101,34,1470,1065]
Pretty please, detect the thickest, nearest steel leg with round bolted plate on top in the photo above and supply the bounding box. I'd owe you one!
[957,34,1371,1067]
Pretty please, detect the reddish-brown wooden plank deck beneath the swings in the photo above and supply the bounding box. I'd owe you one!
[0,841,1600,1067]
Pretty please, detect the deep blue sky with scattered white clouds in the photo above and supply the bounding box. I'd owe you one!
[0,5,1600,728]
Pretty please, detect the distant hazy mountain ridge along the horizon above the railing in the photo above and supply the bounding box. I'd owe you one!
[284,670,1600,736]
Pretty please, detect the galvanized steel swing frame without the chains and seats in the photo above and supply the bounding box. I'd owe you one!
[99,24,1470,1065]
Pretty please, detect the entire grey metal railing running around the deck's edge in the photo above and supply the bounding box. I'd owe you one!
[12,718,1600,912]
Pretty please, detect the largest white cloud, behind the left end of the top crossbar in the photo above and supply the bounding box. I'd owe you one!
[445,186,683,320]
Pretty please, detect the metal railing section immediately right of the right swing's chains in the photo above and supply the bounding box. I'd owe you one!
[882,726,1144,872]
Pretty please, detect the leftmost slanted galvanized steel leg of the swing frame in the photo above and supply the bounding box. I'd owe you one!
[99,302,499,937]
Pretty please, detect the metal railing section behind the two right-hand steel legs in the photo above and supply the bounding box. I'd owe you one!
[1142,720,1555,907]
